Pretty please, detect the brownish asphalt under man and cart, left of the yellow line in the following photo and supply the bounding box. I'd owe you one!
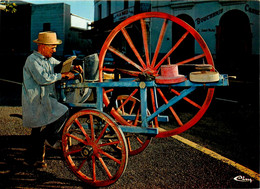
[0,106,259,189]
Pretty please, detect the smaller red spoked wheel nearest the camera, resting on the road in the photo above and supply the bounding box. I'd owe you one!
[62,109,128,186]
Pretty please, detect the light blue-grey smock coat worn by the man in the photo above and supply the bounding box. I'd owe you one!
[22,51,68,127]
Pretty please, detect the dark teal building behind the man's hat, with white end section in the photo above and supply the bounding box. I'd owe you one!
[0,1,91,57]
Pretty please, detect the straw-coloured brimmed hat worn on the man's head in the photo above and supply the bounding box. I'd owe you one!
[33,31,62,45]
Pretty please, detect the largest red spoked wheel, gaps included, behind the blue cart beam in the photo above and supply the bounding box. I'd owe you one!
[99,12,214,137]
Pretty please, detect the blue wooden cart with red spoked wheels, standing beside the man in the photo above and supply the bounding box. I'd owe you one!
[60,12,228,186]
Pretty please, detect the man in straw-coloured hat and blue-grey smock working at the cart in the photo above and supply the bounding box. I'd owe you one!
[22,32,82,167]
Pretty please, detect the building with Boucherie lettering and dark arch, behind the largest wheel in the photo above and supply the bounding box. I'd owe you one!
[95,0,260,79]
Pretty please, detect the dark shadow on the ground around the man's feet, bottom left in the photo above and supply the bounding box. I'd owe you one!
[0,135,88,188]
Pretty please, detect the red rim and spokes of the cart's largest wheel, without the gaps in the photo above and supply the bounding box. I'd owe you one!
[99,12,214,140]
